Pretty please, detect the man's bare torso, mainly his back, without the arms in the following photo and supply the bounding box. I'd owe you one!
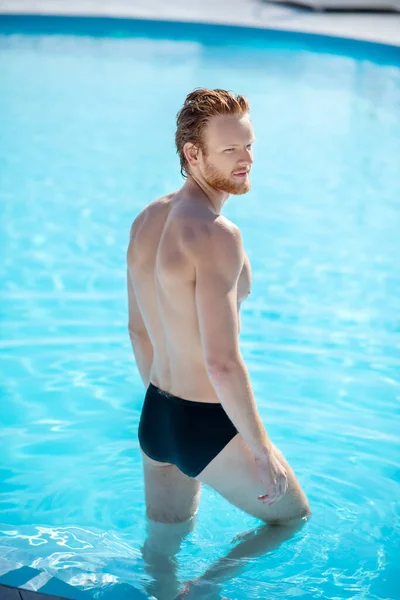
[127,192,251,402]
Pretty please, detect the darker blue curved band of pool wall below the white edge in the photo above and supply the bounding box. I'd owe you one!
[0,14,400,68]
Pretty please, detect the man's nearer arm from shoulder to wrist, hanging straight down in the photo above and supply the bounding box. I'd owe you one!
[185,220,270,456]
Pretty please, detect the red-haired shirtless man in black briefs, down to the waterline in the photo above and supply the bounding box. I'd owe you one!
[127,89,310,524]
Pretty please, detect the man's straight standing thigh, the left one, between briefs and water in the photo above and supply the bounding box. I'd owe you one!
[142,452,201,523]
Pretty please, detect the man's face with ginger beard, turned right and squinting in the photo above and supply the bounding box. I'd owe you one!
[199,115,254,195]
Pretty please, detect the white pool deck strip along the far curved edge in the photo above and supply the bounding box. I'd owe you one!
[0,0,400,47]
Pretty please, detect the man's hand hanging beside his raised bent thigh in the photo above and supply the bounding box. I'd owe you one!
[255,449,288,506]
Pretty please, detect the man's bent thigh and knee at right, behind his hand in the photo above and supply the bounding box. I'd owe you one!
[198,434,310,523]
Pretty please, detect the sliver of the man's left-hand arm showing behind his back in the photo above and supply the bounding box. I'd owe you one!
[127,269,153,388]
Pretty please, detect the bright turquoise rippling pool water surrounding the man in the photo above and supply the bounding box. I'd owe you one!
[0,18,400,600]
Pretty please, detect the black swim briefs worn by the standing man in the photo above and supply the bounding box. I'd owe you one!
[139,383,237,477]
